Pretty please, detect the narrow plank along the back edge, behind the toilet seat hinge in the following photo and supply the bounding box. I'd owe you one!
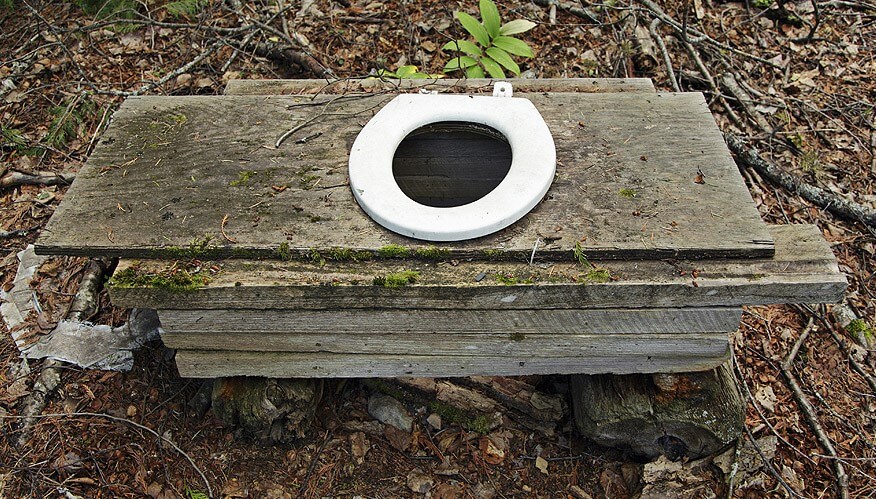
[225,78,656,95]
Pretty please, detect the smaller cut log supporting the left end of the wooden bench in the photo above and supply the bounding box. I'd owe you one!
[212,377,323,442]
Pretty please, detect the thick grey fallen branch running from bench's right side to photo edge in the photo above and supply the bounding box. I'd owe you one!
[724,133,876,228]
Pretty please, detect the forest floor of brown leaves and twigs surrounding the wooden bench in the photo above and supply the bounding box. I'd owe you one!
[0,0,876,498]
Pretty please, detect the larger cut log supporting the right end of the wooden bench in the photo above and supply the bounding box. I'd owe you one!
[570,363,745,460]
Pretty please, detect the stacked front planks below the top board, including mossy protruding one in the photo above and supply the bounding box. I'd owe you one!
[110,225,846,377]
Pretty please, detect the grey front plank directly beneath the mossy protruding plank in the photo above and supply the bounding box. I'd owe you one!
[158,308,742,336]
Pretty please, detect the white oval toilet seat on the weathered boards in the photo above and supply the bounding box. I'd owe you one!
[349,89,556,241]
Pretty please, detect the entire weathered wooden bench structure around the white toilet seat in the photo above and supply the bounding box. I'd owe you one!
[37,79,846,378]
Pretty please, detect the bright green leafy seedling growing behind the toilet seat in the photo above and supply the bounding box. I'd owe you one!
[441,0,535,78]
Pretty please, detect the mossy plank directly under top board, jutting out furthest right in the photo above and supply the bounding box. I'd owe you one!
[109,225,846,310]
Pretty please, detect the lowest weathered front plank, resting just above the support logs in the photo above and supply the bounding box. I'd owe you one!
[176,348,729,378]
